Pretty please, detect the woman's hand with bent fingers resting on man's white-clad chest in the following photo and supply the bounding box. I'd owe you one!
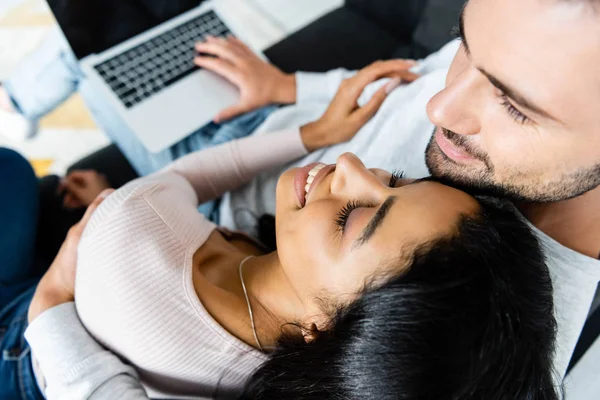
[300,60,419,151]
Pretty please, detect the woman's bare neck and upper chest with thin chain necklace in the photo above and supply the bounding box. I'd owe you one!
[192,232,305,348]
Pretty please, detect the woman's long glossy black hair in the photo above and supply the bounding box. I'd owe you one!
[242,198,558,400]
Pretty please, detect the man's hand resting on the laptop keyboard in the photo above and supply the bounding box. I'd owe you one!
[194,36,296,123]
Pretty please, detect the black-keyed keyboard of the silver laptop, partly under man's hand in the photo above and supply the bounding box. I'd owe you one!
[94,11,230,108]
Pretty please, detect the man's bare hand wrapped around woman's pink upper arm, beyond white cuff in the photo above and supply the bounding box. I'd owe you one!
[28,189,114,322]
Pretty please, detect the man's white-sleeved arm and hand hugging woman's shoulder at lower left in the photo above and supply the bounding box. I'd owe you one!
[25,191,148,400]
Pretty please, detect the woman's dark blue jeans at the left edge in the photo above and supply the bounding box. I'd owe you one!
[0,148,43,400]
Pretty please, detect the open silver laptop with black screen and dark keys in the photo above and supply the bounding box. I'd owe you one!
[48,0,251,153]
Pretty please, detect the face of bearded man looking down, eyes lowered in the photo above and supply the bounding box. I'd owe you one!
[427,0,600,202]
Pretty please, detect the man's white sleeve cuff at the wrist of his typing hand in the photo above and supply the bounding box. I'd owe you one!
[296,68,357,104]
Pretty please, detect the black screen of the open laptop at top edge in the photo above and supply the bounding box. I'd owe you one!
[48,0,202,59]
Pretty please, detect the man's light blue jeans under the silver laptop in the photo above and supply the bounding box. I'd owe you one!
[3,29,275,222]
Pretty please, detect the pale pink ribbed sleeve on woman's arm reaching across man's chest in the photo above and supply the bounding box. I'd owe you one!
[158,128,307,203]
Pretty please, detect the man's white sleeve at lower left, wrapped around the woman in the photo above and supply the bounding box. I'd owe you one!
[25,303,148,400]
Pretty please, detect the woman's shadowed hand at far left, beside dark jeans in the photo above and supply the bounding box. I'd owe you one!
[58,170,110,208]
